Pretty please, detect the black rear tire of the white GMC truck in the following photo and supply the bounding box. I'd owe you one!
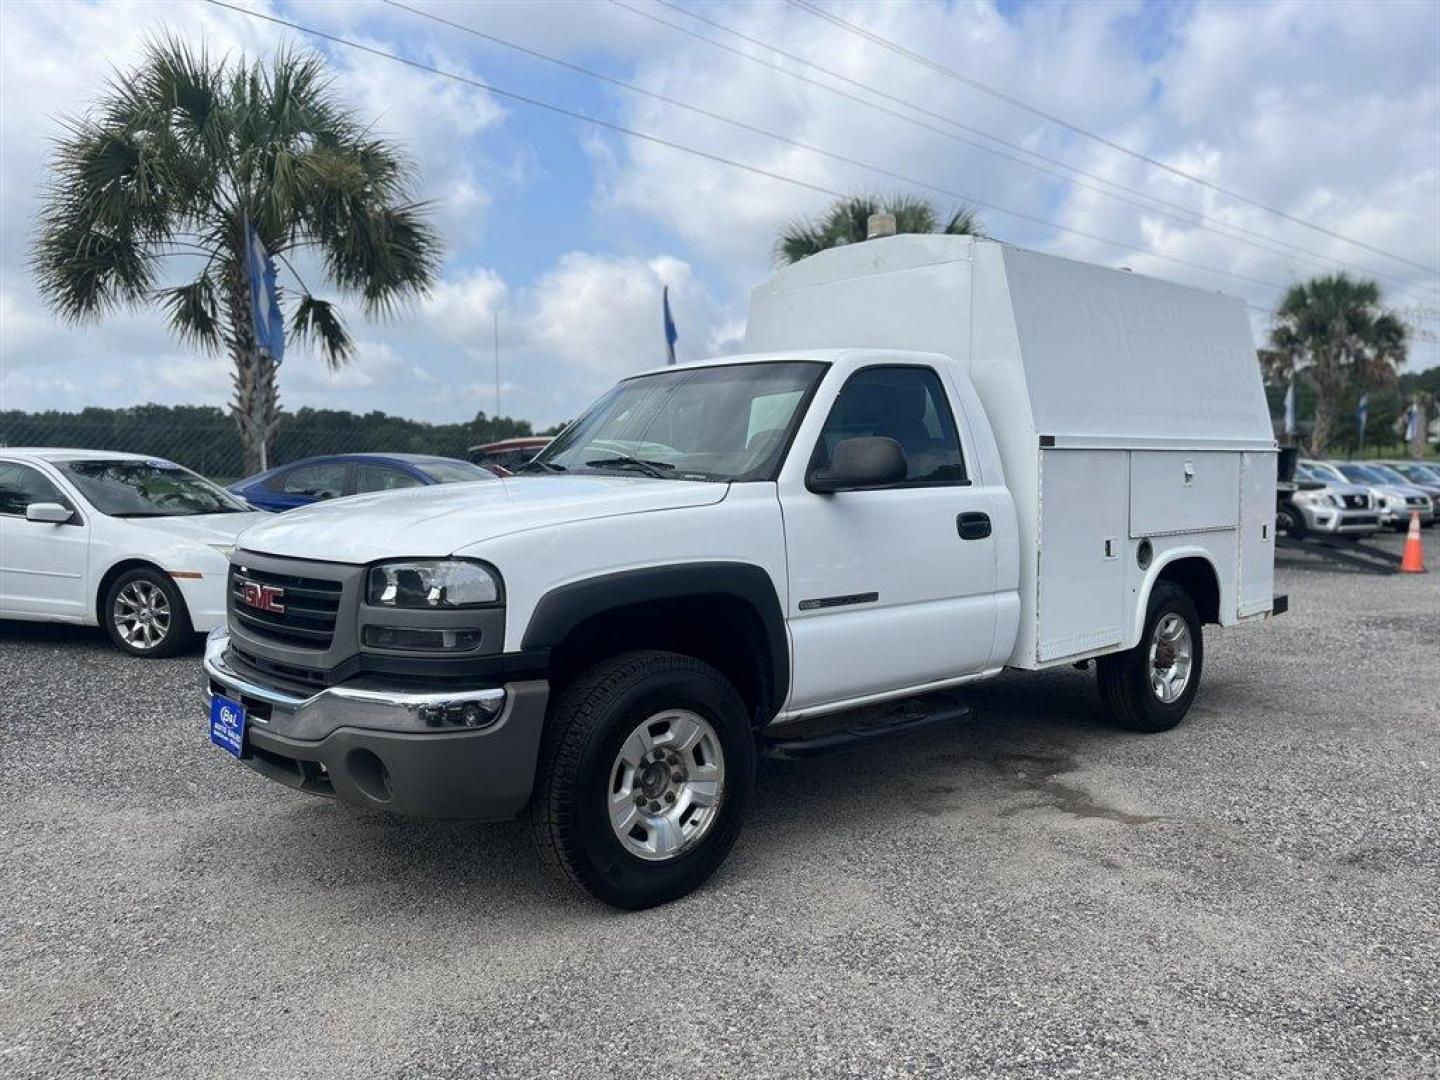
[1096,580,1205,733]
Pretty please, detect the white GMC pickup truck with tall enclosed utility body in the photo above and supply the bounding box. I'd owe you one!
[204,236,1284,907]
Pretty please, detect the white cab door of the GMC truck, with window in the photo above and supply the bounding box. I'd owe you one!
[779,364,996,710]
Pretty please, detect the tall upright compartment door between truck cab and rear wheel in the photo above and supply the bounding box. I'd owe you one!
[1035,449,1132,662]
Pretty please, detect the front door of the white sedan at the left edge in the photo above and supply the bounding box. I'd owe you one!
[0,461,92,621]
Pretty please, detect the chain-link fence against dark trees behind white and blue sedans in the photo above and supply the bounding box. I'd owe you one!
[0,405,533,484]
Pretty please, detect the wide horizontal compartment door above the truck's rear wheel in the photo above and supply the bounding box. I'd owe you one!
[1130,451,1240,537]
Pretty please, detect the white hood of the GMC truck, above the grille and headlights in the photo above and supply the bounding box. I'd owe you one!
[240,475,729,563]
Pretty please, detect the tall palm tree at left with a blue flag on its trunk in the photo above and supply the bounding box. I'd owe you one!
[32,37,439,471]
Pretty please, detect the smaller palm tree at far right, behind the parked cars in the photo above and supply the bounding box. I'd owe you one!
[1261,274,1407,455]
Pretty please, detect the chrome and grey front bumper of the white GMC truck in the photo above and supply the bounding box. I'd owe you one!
[204,631,550,821]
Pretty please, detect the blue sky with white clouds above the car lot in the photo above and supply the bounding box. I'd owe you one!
[0,0,1440,423]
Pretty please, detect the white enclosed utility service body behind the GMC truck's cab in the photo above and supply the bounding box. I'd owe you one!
[746,236,1276,670]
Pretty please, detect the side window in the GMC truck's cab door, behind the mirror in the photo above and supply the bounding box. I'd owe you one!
[811,366,969,485]
